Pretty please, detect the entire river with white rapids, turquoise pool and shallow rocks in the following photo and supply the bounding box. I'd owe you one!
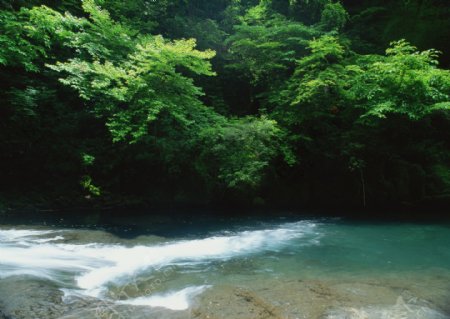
[0,212,450,319]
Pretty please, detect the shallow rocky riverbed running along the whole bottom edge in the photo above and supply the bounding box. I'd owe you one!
[0,275,450,319]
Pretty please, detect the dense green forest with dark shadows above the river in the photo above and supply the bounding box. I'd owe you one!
[0,0,450,209]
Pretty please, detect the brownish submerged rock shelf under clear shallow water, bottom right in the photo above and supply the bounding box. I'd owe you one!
[193,280,450,319]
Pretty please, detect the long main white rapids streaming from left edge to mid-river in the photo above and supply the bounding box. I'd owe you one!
[0,222,315,302]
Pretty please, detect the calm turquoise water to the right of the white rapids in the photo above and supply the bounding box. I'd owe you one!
[286,222,450,272]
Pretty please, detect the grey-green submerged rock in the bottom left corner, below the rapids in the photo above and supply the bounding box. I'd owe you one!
[0,276,191,319]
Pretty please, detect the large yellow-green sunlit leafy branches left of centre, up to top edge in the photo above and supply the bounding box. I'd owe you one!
[43,1,214,141]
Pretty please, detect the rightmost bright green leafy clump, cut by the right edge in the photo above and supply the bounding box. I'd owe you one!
[350,41,450,119]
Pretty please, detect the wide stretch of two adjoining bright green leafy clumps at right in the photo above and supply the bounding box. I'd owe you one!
[284,35,450,119]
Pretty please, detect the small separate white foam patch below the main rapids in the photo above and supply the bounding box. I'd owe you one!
[120,286,210,310]
